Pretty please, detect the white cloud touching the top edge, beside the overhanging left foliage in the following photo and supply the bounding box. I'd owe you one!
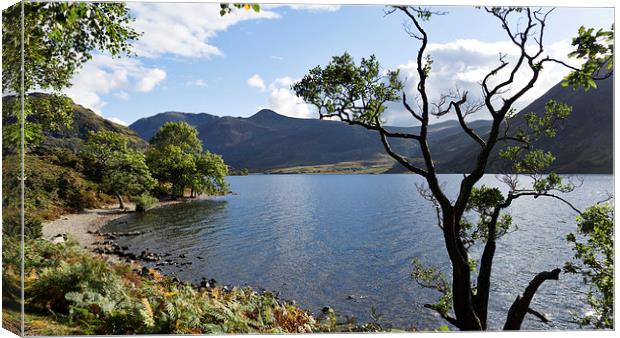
[128,2,280,57]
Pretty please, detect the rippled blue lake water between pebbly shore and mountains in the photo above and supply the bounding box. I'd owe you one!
[107,175,613,329]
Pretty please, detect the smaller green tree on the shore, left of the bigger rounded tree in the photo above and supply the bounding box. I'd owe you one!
[102,150,156,209]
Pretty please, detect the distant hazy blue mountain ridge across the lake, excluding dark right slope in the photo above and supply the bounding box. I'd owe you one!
[130,109,488,172]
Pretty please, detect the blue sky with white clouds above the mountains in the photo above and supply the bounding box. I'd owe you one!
[60,3,614,126]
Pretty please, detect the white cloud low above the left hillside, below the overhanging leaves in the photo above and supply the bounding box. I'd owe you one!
[64,54,166,114]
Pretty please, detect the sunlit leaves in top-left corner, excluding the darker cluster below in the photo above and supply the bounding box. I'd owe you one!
[2,2,139,93]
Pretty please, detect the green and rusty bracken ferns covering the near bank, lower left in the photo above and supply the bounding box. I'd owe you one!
[3,240,392,335]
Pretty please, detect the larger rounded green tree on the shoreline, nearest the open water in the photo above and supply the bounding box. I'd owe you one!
[147,122,228,197]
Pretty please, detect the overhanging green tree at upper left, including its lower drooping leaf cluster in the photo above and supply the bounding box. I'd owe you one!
[2,1,139,149]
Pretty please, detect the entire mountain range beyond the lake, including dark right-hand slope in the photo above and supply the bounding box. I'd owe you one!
[130,75,613,173]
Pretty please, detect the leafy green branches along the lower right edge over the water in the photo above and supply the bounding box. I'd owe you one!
[564,204,614,329]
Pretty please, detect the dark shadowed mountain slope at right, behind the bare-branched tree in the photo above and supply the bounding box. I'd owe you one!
[441,76,614,174]
